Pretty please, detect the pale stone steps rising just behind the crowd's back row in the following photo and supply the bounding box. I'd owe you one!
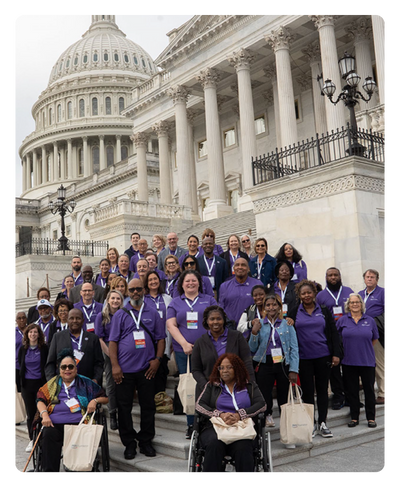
[178,210,257,251]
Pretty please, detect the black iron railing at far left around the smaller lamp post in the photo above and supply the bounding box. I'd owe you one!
[12,238,108,258]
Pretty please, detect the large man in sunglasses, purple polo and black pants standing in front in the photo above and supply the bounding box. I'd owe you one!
[109,278,165,460]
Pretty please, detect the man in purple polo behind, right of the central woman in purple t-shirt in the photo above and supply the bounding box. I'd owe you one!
[219,257,264,325]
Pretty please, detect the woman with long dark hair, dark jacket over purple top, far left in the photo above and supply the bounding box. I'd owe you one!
[18,323,49,451]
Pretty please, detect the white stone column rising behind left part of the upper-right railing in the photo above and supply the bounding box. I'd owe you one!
[265,27,298,147]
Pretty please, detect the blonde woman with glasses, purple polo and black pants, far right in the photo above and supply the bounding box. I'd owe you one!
[336,293,379,427]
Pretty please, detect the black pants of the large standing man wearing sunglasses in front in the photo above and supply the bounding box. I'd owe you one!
[116,370,156,447]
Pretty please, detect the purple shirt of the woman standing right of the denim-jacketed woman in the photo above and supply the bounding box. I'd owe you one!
[295,304,330,359]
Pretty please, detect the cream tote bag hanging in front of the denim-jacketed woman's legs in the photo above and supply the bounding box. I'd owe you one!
[280,384,314,444]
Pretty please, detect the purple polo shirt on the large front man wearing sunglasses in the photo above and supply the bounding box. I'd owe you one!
[109,302,165,373]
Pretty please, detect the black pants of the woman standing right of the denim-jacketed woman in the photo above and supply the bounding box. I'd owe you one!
[299,356,332,424]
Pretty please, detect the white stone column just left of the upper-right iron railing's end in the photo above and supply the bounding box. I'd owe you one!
[228,49,257,189]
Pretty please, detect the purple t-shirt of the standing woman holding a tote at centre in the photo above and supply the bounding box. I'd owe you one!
[167,293,217,352]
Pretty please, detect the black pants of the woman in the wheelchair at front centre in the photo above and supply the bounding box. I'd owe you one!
[200,427,254,476]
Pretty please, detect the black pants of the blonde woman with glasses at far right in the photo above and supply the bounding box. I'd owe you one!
[342,365,375,420]
